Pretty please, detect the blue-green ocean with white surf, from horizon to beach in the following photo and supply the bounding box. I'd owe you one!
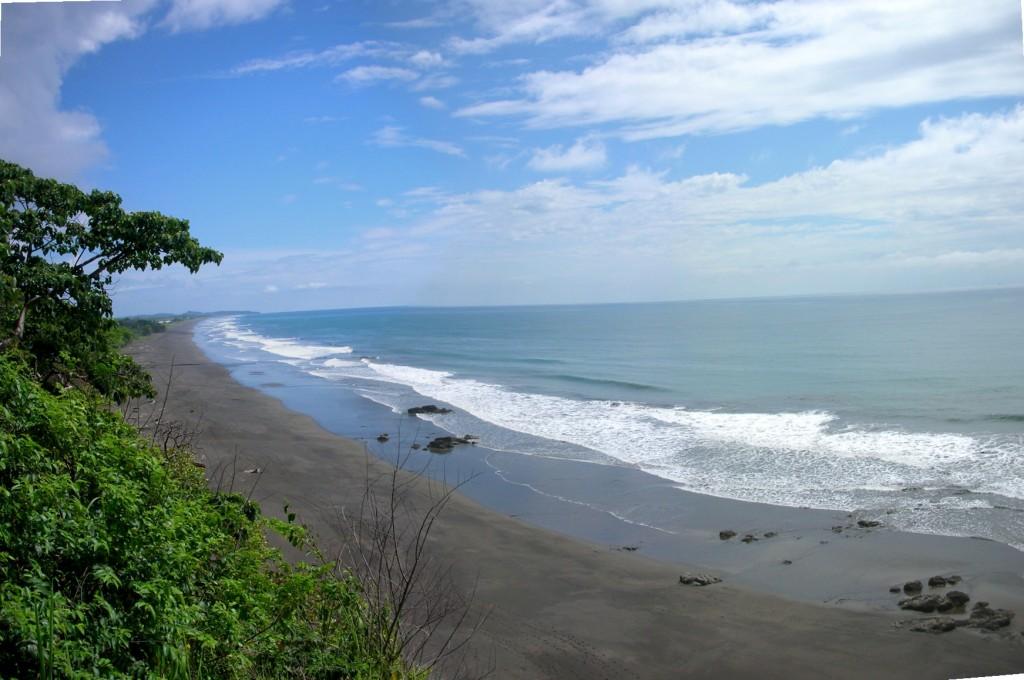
[196,289,1024,549]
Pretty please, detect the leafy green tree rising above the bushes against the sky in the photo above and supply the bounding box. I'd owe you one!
[0,160,223,399]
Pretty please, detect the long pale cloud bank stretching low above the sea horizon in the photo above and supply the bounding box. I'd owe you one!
[119,108,1024,309]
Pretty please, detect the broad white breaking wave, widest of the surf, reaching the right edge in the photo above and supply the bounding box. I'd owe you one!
[354,360,1024,509]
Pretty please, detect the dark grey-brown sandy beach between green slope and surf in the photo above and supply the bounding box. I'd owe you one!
[129,322,1024,678]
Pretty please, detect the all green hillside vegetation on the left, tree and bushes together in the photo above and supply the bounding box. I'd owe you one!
[0,162,425,678]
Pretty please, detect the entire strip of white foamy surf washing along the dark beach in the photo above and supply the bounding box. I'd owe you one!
[200,317,1024,548]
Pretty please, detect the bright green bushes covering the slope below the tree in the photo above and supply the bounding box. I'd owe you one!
[0,354,425,678]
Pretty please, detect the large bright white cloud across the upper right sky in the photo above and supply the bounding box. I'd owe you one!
[459,0,1024,139]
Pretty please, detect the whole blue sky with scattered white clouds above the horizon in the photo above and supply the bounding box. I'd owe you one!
[0,0,1024,314]
